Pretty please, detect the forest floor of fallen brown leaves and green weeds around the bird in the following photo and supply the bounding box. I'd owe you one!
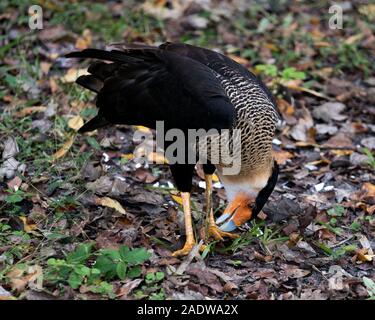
[0,0,375,300]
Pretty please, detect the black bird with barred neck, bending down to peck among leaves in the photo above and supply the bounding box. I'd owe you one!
[65,42,280,257]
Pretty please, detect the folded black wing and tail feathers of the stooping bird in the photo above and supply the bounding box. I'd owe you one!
[66,48,235,132]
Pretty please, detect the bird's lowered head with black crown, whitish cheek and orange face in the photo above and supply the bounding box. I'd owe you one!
[216,161,279,232]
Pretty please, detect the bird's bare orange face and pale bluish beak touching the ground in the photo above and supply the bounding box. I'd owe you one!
[216,197,252,232]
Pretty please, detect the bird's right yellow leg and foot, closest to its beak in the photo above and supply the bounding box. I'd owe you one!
[204,174,239,240]
